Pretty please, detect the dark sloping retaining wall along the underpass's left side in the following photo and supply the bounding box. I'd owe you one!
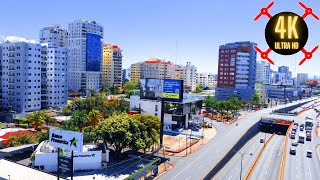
[203,121,260,180]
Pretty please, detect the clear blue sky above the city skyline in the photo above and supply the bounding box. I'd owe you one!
[0,0,320,76]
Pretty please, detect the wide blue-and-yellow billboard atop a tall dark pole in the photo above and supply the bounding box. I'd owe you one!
[140,79,183,102]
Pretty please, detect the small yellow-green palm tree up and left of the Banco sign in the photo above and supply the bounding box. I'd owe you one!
[26,110,48,131]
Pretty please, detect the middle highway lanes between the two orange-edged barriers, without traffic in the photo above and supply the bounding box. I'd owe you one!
[250,134,285,179]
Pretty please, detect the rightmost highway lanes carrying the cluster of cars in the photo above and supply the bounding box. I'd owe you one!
[284,109,320,180]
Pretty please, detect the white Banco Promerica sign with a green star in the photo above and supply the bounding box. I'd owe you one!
[49,128,83,152]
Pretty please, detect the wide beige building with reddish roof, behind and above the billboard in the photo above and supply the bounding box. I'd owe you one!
[140,58,175,79]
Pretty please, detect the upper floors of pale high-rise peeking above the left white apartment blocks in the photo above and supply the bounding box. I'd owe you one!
[40,25,68,47]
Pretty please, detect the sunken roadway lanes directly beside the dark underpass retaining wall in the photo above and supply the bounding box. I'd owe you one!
[213,133,271,180]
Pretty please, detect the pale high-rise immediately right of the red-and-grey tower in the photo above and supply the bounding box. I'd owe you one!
[256,61,271,84]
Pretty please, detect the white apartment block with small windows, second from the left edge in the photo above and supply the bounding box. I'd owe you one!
[41,46,68,108]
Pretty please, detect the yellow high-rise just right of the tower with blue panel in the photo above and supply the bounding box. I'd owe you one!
[102,44,122,88]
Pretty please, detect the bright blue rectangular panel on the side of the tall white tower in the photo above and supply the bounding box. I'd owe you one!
[86,33,102,72]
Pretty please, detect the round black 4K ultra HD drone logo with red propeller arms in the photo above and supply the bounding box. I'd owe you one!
[254,2,319,65]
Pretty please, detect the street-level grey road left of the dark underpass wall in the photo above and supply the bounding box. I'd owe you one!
[159,99,316,180]
